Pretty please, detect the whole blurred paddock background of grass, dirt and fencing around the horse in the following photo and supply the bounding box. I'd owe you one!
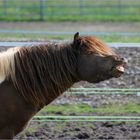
[0,0,140,140]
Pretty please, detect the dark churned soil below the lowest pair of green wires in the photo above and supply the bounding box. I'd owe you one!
[17,122,140,140]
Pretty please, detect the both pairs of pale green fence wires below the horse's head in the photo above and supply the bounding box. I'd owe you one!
[32,88,140,122]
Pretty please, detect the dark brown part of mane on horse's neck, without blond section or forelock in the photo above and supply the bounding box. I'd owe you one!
[13,44,79,105]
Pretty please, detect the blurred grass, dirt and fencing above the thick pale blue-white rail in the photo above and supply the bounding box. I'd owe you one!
[0,0,140,42]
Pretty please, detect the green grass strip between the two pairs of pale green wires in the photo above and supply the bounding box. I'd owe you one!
[38,103,140,115]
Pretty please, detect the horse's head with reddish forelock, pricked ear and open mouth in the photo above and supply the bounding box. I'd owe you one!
[73,33,126,83]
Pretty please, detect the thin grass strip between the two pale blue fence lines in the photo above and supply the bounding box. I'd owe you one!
[0,33,140,43]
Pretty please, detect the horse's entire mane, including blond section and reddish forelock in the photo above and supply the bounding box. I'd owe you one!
[0,36,114,105]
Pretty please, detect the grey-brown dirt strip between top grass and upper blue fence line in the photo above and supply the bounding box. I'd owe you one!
[0,22,140,32]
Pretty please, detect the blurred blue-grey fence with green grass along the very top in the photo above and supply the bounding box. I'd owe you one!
[0,0,140,21]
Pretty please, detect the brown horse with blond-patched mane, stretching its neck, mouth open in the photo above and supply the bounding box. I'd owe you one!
[0,33,125,139]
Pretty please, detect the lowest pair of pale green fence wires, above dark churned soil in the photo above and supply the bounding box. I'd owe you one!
[32,116,140,122]
